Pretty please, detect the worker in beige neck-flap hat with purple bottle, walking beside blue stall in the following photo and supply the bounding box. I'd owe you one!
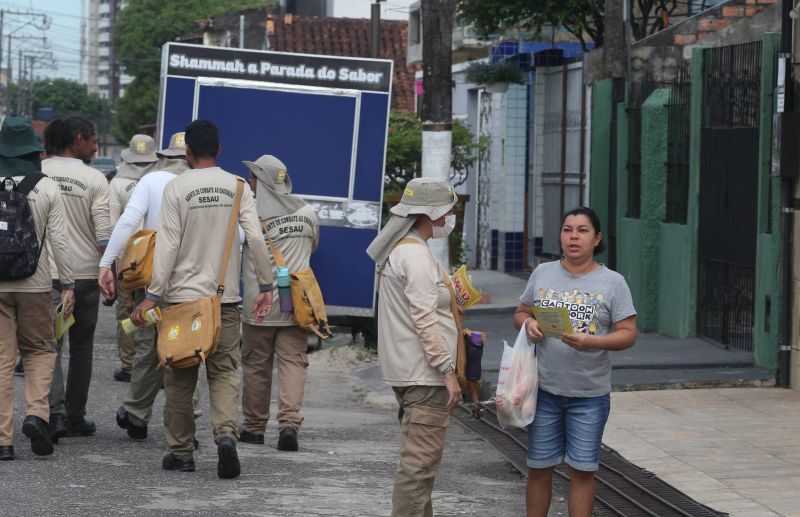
[239,155,319,451]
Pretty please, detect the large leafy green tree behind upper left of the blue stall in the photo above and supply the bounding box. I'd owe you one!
[112,0,272,142]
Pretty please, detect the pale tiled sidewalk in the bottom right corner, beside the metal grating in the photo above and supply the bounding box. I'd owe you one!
[603,388,800,517]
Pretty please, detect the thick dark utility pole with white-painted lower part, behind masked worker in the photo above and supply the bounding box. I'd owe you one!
[422,0,453,271]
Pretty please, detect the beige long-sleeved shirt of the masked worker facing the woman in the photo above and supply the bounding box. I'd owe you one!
[378,230,458,386]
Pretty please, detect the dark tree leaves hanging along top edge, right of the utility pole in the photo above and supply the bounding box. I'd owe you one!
[455,0,605,49]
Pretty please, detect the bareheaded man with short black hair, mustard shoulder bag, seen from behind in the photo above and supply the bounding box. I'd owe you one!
[132,120,272,478]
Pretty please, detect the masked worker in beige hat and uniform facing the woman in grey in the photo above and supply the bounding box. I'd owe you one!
[367,178,461,517]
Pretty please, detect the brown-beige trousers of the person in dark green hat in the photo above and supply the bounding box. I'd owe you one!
[0,292,56,445]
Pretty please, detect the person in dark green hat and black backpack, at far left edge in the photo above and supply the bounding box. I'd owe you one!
[0,117,75,460]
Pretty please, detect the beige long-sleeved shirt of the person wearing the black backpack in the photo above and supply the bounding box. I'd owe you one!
[0,176,75,293]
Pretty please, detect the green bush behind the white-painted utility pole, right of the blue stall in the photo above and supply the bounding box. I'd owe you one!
[385,110,489,192]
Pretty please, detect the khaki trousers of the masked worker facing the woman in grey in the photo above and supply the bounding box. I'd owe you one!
[392,386,450,517]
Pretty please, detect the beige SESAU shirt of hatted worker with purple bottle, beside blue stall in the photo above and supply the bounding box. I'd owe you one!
[242,205,319,327]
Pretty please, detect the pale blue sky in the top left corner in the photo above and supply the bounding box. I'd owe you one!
[0,0,83,80]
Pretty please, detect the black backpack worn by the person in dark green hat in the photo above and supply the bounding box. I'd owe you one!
[0,172,47,281]
